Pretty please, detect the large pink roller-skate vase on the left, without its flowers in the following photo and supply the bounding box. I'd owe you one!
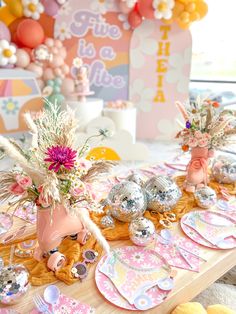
[34,205,88,271]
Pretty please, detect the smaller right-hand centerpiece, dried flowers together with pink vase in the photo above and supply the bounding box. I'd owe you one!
[176,98,236,192]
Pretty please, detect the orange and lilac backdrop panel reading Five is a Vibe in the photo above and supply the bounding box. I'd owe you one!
[55,0,132,101]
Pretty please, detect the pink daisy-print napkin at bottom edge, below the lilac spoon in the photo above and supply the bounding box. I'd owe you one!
[30,294,95,314]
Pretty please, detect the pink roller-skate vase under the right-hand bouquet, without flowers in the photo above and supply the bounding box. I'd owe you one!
[184,147,213,192]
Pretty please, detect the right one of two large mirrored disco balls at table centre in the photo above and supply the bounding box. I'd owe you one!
[144,176,182,213]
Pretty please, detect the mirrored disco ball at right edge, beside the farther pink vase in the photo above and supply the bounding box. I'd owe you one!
[212,156,236,184]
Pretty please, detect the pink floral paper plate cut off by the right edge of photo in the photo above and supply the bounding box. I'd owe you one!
[180,210,236,250]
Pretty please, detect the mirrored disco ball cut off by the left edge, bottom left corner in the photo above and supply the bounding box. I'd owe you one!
[0,265,30,305]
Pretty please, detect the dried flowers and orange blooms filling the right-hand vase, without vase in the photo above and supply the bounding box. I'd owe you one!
[176,97,236,151]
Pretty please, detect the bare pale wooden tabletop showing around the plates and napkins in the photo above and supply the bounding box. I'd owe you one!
[0,213,236,314]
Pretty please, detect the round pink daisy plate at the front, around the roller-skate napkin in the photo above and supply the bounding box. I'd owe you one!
[95,246,171,311]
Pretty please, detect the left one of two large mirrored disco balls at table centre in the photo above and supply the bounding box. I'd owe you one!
[107,181,147,222]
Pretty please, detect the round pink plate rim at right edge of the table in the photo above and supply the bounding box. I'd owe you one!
[180,210,236,250]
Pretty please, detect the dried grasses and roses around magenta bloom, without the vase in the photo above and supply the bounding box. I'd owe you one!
[0,103,113,213]
